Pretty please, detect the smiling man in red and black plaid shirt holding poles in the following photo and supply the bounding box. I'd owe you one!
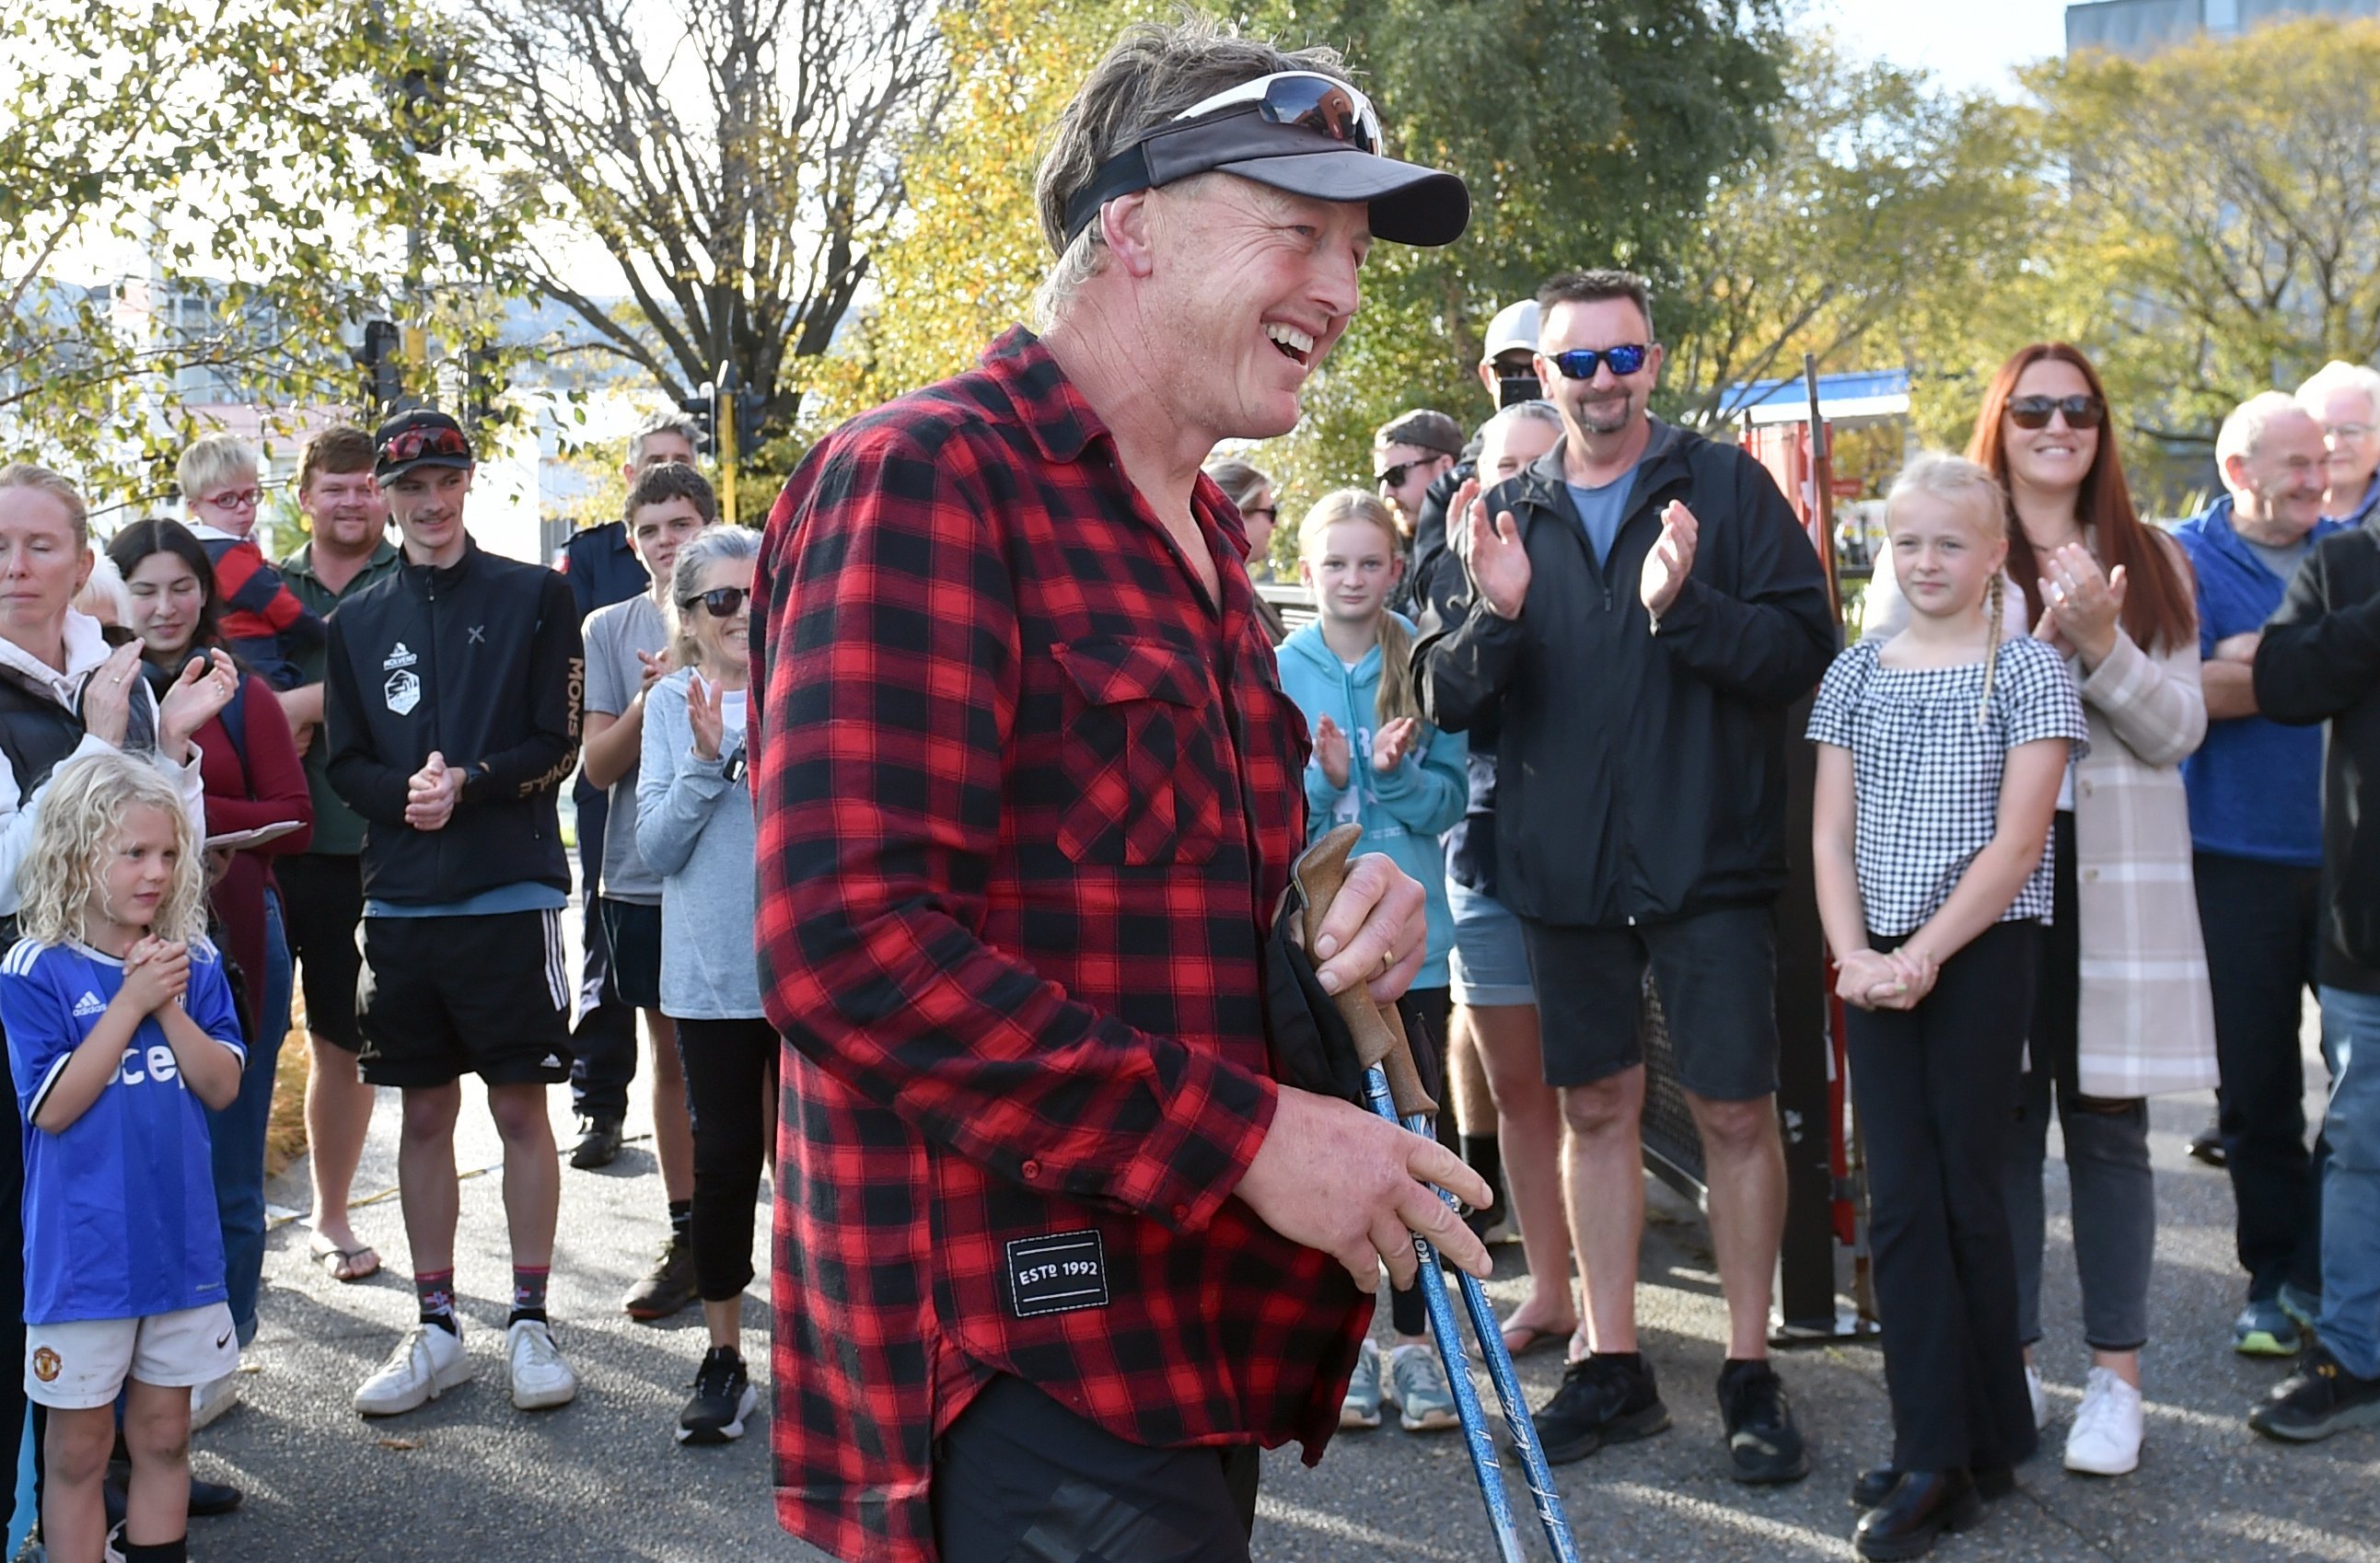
[754,21,1488,1563]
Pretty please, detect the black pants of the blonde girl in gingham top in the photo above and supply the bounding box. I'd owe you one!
[1850,920,2039,1470]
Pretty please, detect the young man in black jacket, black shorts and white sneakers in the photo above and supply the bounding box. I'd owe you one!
[324,411,586,1416]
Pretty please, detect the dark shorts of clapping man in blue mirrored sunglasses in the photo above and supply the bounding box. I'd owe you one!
[1521,907,1778,1102]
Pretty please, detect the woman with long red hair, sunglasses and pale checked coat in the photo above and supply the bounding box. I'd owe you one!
[1966,342,2216,1475]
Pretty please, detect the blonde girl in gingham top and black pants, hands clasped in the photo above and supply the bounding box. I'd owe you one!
[1809,457,2087,1558]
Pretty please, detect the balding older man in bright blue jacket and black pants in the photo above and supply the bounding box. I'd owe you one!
[2173,390,2344,1356]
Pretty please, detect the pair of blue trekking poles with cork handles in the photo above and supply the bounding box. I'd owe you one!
[1294,826,1580,1563]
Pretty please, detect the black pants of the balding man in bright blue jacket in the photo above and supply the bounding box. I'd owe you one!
[2194,851,2330,1302]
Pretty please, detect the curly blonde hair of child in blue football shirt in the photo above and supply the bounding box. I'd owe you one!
[17,754,207,944]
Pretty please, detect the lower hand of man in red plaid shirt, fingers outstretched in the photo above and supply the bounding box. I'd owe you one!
[1233,1084,1494,1291]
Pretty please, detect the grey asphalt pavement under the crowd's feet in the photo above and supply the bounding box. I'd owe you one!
[191,913,2380,1563]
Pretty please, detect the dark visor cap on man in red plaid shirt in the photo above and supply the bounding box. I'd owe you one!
[1066,107,1471,248]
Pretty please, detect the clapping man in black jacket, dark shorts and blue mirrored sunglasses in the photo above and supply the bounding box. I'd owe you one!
[1416,272,1835,1482]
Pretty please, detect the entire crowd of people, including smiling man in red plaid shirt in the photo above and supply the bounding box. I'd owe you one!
[0,21,2380,1563]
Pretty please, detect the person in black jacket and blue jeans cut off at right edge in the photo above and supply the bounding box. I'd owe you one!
[2249,514,2380,1441]
